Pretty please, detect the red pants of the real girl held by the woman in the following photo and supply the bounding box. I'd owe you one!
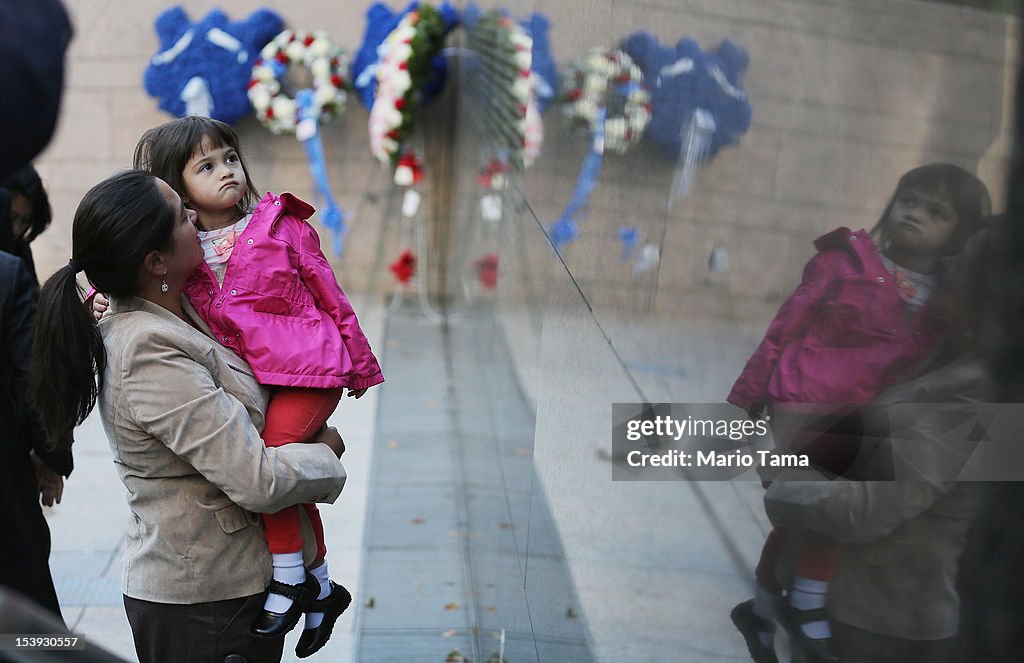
[263,386,344,562]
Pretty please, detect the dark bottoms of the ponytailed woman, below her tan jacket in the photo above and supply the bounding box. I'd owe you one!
[124,593,285,663]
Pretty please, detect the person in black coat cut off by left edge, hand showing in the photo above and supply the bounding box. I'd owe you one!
[0,250,74,617]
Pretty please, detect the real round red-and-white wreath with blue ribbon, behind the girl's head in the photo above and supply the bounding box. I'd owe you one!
[249,30,348,255]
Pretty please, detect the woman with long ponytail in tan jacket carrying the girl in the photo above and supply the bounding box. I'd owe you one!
[33,171,345,663]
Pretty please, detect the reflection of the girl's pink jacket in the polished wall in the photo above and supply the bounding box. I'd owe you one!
[728,227,938,410]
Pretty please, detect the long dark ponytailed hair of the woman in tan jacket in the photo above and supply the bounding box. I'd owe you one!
[31,170,176,445]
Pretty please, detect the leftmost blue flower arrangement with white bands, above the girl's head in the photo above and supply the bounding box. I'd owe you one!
[142,6,284,124]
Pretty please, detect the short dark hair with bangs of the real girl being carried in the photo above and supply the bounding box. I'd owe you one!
[133,115,259,217]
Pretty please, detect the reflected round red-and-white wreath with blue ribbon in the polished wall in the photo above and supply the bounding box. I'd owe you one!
[549,48,651,252]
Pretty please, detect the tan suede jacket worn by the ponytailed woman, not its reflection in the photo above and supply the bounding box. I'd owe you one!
[99,298,345,604]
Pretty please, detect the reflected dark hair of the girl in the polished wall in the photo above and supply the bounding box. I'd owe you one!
[871,163,992,256]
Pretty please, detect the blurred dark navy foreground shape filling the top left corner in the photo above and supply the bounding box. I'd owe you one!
[0,0,72,179]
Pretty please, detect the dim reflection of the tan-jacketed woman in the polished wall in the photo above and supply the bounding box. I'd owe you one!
[765,240,987,663]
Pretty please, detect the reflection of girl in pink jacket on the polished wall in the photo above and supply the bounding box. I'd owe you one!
[728,164,990,663]
